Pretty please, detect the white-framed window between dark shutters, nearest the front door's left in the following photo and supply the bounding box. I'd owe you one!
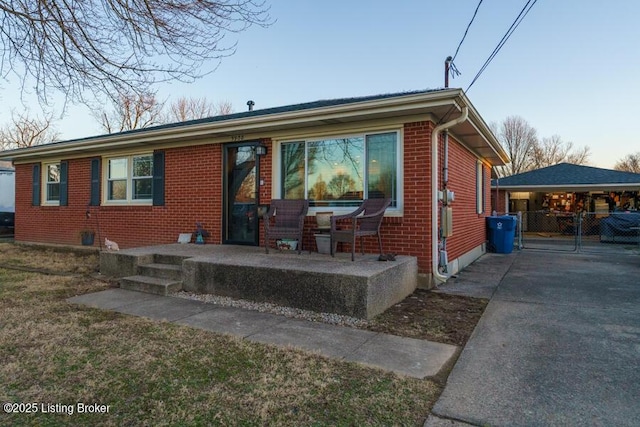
[105,154,153,203]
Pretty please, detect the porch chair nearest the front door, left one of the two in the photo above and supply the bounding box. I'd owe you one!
[263,199,309,254]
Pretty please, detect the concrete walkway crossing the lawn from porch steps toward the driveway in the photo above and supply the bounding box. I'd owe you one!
[68,289,457,378]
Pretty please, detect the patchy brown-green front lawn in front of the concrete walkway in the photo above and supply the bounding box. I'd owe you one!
[0,269,441,426]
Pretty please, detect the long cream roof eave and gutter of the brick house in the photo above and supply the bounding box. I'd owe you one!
[0,89,507,164]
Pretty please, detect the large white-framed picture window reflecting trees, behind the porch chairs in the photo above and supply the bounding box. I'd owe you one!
[280,132,399,207]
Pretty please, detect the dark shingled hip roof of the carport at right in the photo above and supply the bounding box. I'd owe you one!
[491,163,640,191]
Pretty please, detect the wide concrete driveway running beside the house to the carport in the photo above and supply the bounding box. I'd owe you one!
[426,251,640,427]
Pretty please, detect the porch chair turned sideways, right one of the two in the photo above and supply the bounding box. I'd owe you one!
[331,199,391,261]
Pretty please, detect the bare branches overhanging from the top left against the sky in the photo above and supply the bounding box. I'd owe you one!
[0,0,272,105]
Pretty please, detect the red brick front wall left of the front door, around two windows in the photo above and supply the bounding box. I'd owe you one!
[15,144,222,248]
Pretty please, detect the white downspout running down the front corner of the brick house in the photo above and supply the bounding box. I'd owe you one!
[431,107,469,284]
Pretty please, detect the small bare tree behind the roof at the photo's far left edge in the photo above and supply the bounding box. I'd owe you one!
[0,111,59,151]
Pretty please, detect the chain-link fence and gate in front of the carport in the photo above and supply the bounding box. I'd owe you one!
[506,212,640,254]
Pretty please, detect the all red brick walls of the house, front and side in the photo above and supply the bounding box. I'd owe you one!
[16,121,490,273]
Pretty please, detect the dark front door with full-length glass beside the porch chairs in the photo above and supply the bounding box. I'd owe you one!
[223,142,260,245]
